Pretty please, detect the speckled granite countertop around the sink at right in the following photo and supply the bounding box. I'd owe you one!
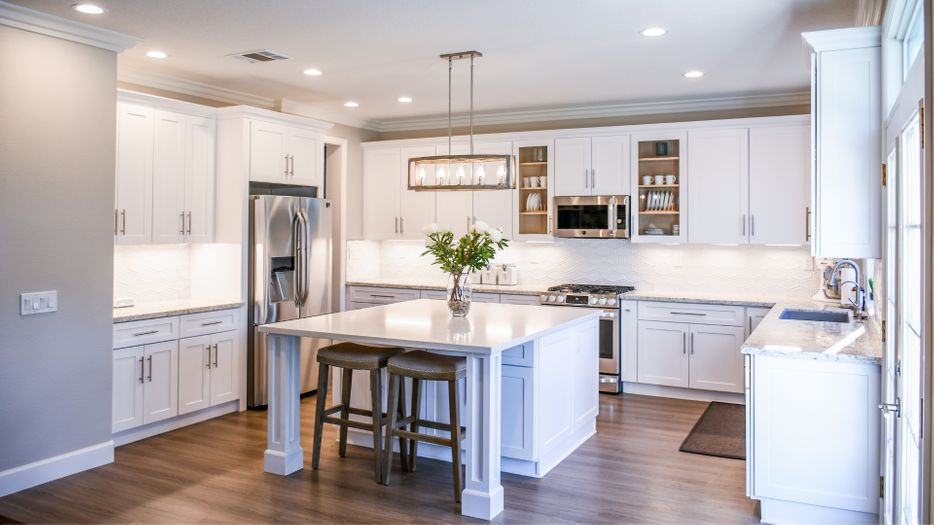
[742,301,884,364]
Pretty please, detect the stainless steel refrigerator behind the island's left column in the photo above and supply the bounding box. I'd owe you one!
[247,183,331,407]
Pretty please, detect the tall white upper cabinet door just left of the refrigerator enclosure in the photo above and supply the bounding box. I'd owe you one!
[185,118,216,242]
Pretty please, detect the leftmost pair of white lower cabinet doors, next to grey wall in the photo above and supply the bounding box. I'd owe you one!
[111,341,178,432]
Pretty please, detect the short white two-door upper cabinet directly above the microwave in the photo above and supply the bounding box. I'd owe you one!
[554,135,631,197]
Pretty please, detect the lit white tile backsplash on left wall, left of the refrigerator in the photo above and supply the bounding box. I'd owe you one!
[114,244,191,303]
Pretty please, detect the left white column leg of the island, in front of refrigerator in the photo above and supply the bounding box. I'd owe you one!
[263,334,305,476]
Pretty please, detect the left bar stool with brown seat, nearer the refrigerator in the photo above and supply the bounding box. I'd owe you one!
[311,343,404,483]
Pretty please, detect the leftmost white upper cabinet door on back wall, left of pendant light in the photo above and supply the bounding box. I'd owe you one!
[363,148,400,241]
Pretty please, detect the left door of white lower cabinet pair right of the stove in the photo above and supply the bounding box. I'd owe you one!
[638,321,690,386]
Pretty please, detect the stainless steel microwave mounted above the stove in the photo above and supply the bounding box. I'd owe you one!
[552,195,629,239]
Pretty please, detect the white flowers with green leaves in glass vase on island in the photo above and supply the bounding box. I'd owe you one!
[422,221,509,317]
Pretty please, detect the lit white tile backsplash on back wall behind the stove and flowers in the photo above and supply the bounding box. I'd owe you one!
[347,239,820,299]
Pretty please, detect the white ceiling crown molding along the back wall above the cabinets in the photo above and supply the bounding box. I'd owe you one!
[374,91,811,132]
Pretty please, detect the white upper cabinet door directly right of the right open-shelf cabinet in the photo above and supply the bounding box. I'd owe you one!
[688,128,749,243]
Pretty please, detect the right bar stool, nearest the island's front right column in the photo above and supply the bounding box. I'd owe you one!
[383,350,467,503]
